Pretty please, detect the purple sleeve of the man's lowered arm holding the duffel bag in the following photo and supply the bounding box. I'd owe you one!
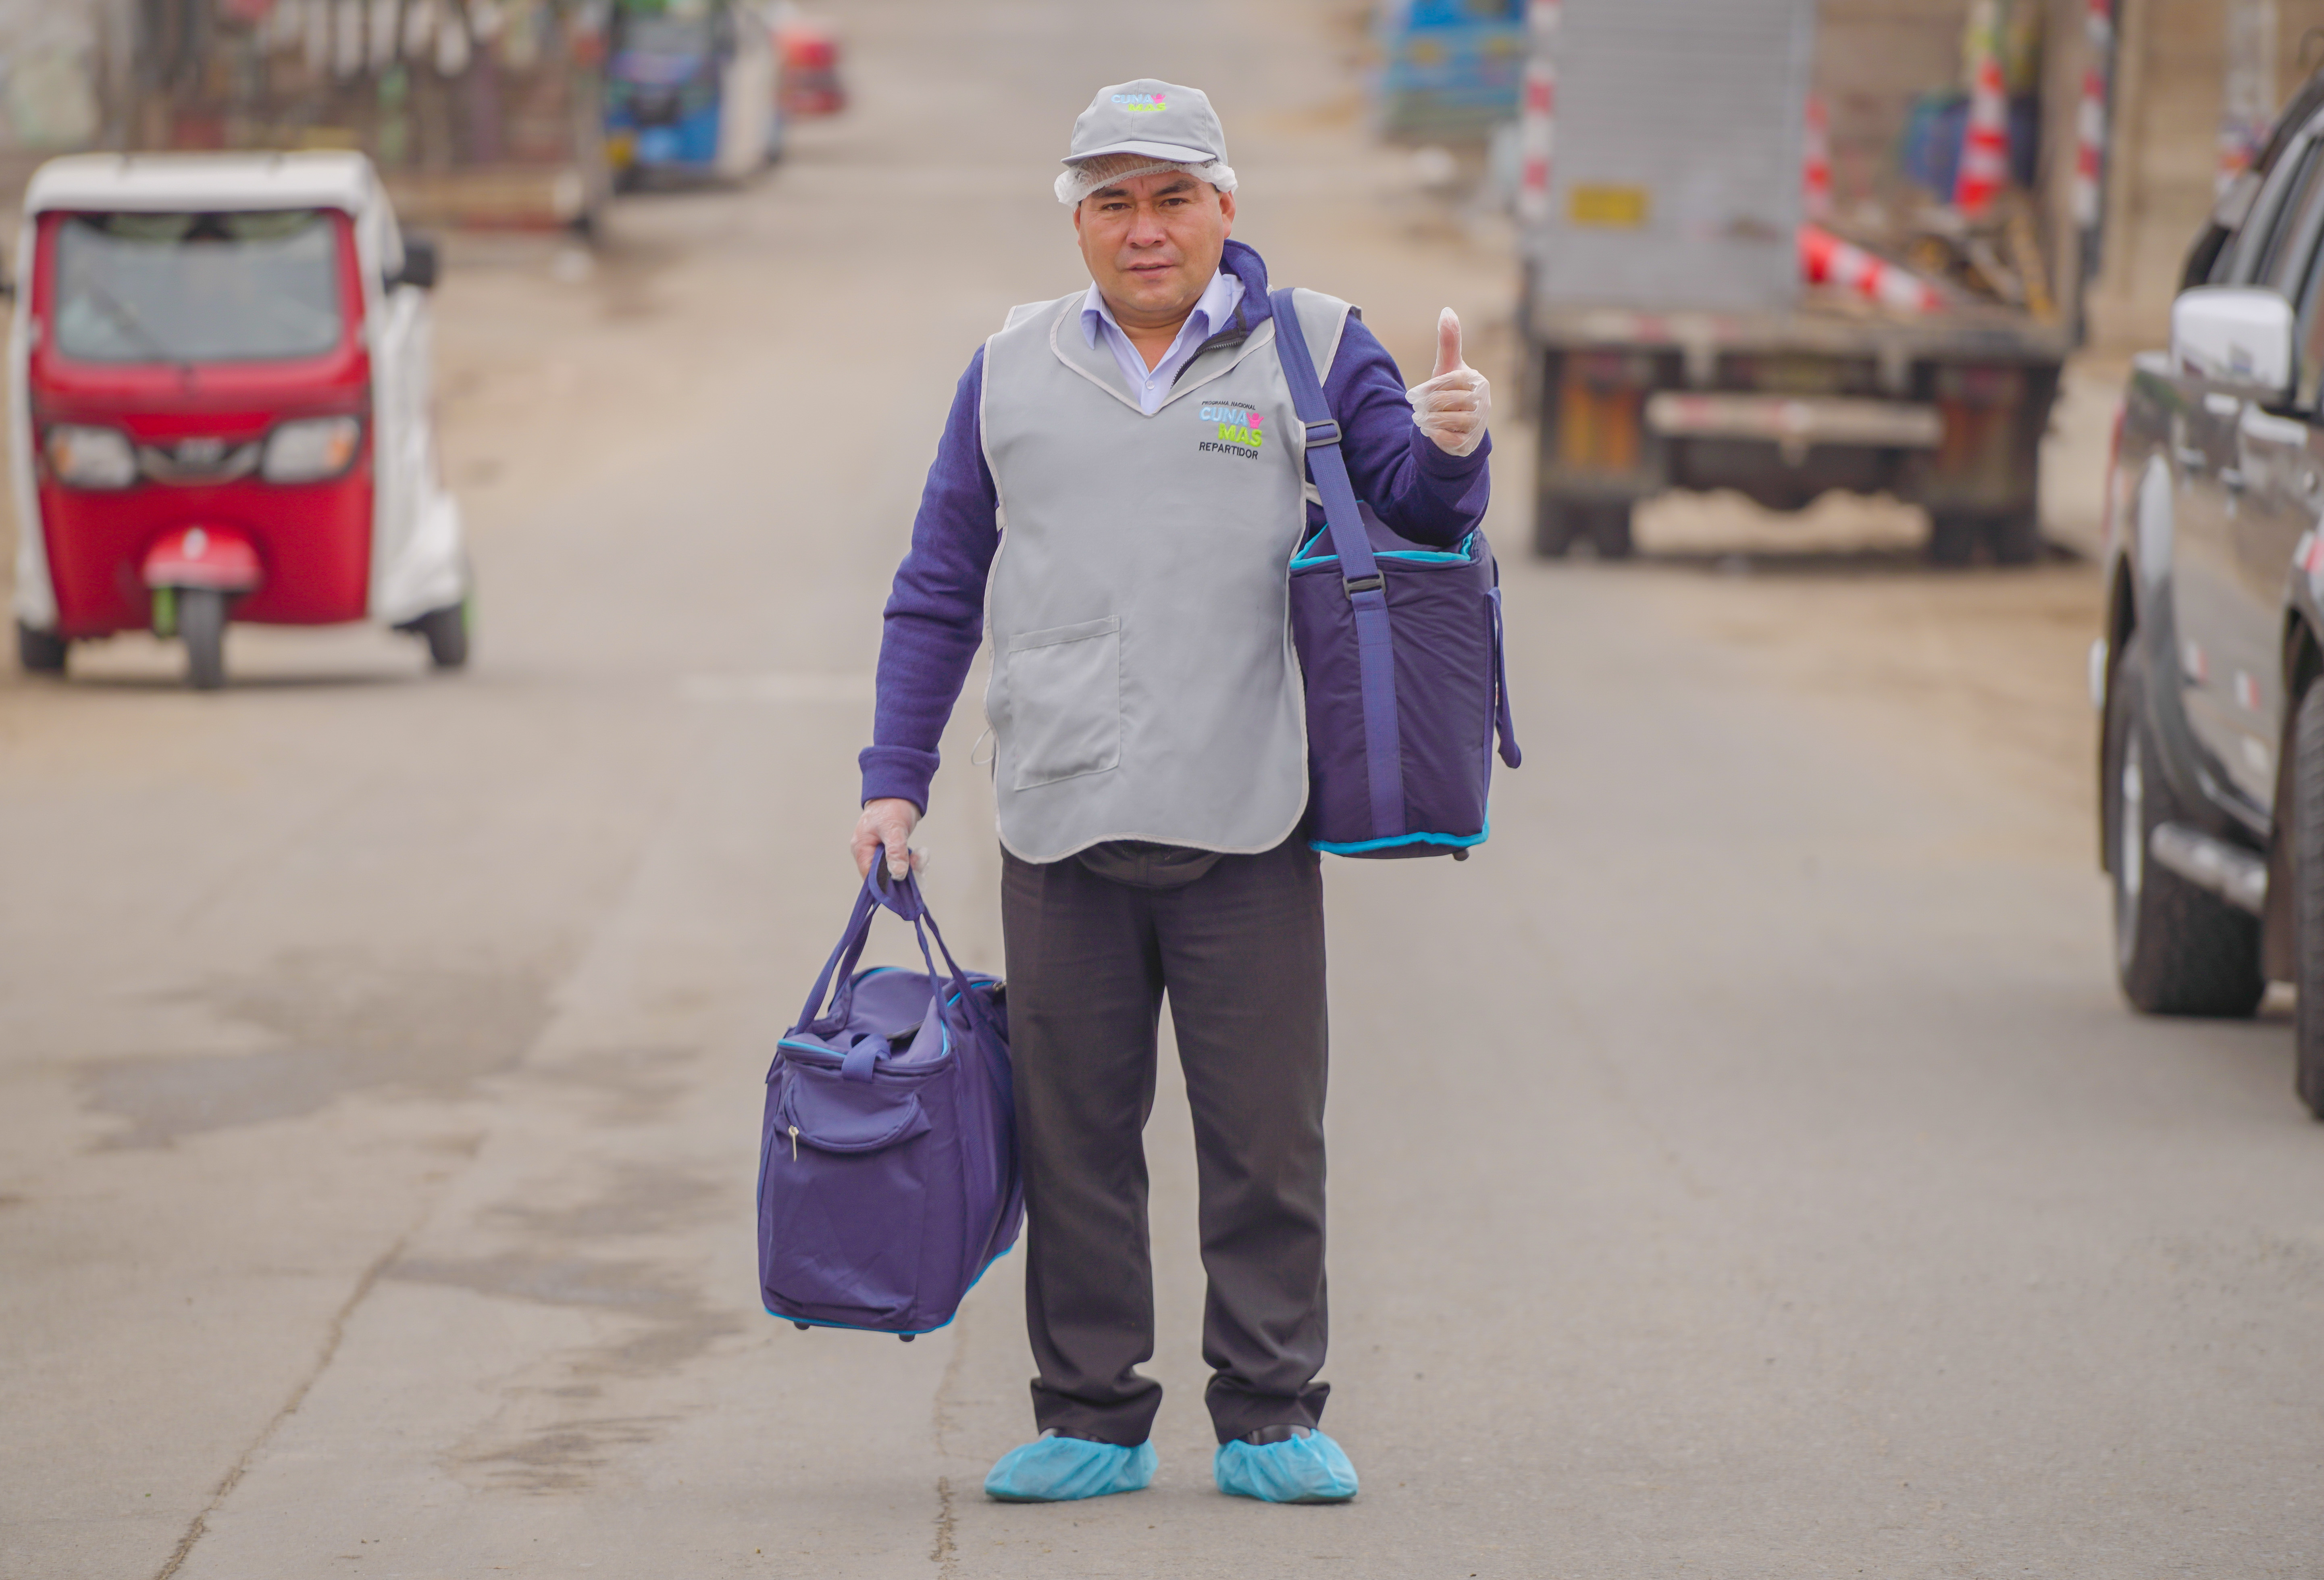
[857,346,1002,813]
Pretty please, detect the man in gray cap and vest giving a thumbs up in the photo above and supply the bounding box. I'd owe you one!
[853,79,1490,1503]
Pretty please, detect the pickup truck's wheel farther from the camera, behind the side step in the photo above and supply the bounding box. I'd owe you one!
[2099,641,2268,1018]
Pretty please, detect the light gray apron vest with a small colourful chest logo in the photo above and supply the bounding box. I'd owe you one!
[981,290,1348,862]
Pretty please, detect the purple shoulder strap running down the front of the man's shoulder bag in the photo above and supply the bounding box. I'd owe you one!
[1267,286,1406,839]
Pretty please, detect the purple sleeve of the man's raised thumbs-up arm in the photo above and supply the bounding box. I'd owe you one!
[1309,311,1492,546]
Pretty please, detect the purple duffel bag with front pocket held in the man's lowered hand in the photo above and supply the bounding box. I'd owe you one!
[757,862,1025,1341]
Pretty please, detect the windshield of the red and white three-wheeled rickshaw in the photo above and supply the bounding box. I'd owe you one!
[51,209,344,362]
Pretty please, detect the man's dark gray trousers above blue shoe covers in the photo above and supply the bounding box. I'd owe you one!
[1002,839,1332,1445]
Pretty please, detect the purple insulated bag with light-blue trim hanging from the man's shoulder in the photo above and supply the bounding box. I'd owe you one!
[1271,288,1522,860]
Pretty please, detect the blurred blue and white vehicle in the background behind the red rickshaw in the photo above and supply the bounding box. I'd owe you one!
[604,0,783,186]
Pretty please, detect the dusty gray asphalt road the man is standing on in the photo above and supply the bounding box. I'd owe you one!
[0,0,2324,1580]
